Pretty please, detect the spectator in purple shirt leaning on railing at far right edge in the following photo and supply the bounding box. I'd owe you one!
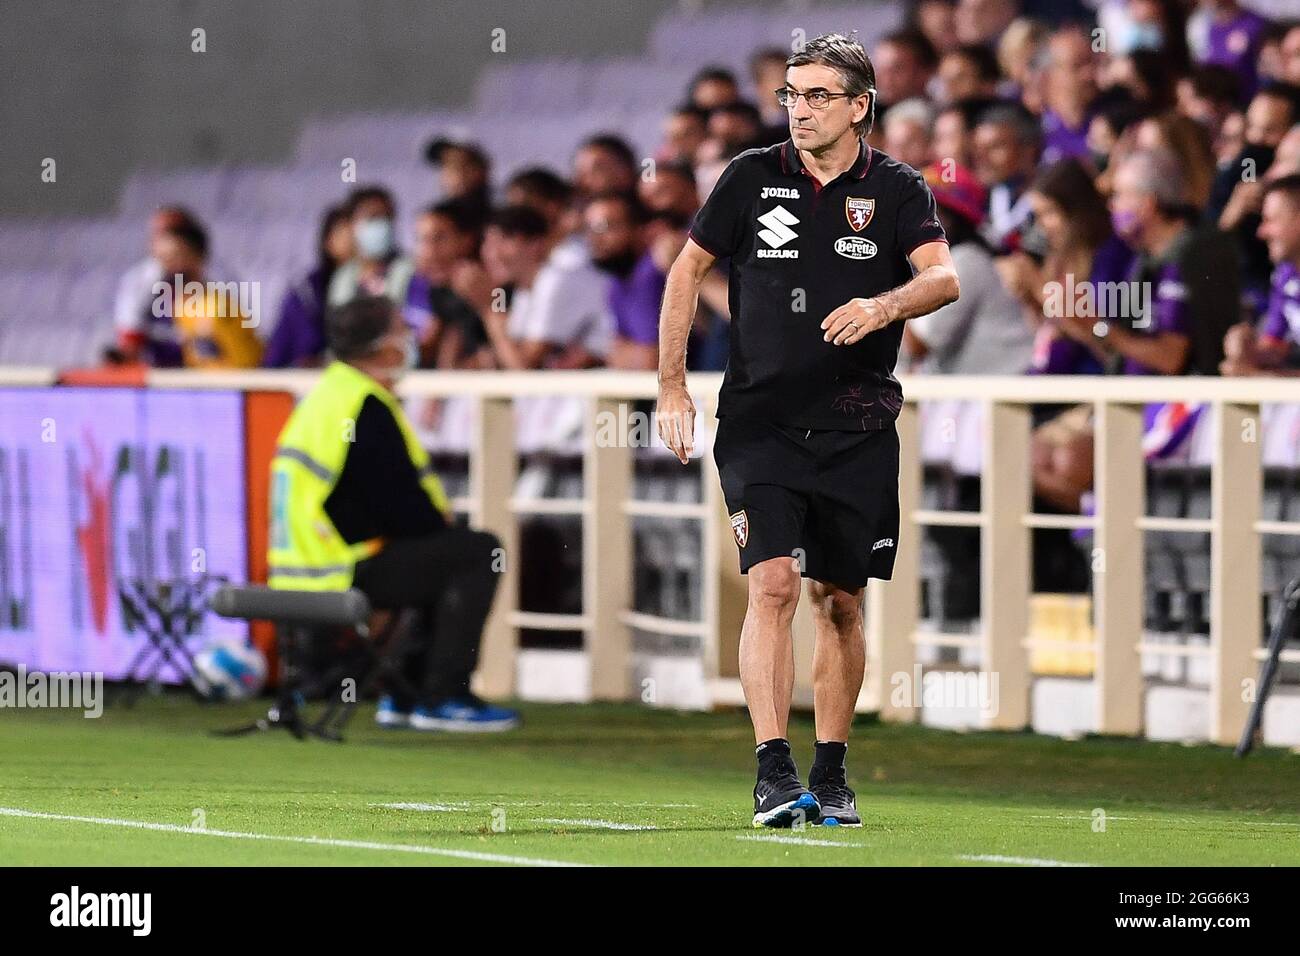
[1221,174,1300,376]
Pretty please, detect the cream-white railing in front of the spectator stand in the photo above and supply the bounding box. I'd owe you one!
[0,368,1300,744]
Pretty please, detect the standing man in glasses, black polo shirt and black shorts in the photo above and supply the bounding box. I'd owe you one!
[657,34,958,826]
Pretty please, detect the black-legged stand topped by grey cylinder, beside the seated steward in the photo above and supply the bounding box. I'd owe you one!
[212,585,415,741]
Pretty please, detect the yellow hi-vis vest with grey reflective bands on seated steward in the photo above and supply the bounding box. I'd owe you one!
[267,362,451,591]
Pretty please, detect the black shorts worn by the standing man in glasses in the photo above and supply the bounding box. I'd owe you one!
[714,416,898,591]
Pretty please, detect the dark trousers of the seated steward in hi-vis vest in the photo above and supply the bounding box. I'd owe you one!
[354,525,501,705]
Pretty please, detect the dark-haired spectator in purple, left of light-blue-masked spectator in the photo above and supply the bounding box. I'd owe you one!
[261,206,352,368]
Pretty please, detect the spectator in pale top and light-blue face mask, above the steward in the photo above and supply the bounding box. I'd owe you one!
[328,186,416,324]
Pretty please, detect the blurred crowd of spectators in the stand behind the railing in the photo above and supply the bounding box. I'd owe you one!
[114,0,1300,510]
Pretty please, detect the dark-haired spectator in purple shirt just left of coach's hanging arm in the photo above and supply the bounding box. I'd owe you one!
[584,193,660,369]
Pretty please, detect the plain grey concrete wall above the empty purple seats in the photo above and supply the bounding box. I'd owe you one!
[0,0,696,217]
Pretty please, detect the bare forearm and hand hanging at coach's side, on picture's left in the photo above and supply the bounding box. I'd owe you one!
[655,239,714,464]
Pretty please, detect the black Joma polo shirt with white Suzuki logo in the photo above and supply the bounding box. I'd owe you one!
[690,139,946,431]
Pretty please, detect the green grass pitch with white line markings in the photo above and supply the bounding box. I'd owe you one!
[0,695,1300,866]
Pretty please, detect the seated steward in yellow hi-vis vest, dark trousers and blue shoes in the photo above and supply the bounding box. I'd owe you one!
[268,295,519,731]
